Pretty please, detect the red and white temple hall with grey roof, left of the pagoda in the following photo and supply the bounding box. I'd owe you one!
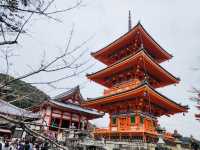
[31,86,102,138]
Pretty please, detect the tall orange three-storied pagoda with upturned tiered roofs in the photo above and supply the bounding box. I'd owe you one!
[83,17,188,142]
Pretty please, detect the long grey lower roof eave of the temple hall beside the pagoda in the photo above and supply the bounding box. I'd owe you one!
[43,100,103,118]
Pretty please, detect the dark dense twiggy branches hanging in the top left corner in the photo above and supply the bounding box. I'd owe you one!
[0,0,82,45]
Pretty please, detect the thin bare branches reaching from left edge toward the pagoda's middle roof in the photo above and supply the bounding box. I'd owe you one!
[0,30,93,89]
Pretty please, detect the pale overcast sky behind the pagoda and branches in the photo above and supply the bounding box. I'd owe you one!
[1,0,200,138]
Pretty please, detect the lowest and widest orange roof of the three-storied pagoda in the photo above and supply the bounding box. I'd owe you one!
[82,82,188,115]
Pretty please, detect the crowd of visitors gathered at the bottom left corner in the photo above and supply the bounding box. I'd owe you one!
[0,138,49,150]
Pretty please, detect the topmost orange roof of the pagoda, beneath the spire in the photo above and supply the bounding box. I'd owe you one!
[91,22,172,65]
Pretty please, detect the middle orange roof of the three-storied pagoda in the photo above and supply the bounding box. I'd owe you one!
[87,49,180,87]
